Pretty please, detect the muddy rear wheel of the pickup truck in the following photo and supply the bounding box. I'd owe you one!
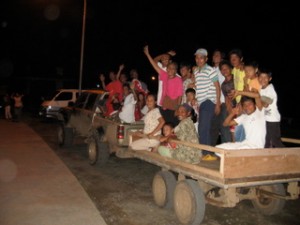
[88,131,109,165]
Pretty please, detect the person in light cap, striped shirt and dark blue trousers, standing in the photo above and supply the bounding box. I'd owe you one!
[193,48,221,161]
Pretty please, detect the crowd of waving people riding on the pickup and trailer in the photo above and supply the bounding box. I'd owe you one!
[99,46,284,163]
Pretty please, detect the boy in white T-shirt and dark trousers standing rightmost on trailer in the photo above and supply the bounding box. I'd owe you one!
[258,69,284,148]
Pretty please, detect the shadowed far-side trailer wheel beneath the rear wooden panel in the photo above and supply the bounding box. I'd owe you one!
[252,184,286,215]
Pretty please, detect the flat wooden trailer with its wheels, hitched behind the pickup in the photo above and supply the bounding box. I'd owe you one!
[129,138,300,225]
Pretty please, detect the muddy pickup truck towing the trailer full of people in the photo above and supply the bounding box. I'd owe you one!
[57,90,144,165]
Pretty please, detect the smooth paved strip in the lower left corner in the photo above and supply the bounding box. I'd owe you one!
[0,119,106,225]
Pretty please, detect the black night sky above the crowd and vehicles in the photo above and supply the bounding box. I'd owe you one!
[0,0,300,116]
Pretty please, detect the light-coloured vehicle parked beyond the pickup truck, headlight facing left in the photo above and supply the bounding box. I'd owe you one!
[39,89,83,119]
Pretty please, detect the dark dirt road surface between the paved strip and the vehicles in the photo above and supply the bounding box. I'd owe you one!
[26,118,300,225]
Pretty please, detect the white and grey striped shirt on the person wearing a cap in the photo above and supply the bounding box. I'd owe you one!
[194,64,218,105]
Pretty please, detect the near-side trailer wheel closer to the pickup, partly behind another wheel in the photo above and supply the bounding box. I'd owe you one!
[152,171,176,208]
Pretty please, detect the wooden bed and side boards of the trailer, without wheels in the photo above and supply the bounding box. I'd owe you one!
[132,141,300,188]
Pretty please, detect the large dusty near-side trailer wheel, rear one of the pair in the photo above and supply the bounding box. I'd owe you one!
[174,179,205,225]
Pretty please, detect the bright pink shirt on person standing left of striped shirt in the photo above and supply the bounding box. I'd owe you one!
[159,70,183,104]
